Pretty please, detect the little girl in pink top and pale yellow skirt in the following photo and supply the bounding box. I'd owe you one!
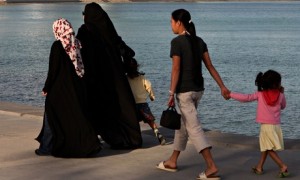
[230,70,289,177]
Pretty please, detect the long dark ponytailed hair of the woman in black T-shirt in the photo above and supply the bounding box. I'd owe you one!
[172,9,202,74]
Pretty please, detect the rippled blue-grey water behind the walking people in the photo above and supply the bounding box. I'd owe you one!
[0,2,300,139]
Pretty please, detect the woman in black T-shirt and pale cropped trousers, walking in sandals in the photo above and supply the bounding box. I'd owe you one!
[157,9,229,179]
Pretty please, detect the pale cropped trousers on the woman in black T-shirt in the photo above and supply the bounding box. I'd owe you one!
[174,91,211,153]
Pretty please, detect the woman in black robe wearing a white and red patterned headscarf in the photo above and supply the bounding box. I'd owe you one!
[35,18,101,157]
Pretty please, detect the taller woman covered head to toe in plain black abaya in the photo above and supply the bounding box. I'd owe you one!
[77,3,142,149]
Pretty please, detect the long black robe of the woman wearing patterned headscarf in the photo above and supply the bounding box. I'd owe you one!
[37,41,101,157]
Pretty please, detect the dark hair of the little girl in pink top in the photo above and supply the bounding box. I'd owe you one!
[255,70,281,91]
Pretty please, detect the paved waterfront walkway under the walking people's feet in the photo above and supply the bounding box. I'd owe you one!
[0,102,300,180]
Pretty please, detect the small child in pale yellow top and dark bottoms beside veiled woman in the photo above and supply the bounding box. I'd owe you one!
[124,58,166,145]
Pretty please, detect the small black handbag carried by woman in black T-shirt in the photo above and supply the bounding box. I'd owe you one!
[160,106,181,130]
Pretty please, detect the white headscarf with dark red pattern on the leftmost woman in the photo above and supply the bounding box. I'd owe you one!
[53,18,84,77]
